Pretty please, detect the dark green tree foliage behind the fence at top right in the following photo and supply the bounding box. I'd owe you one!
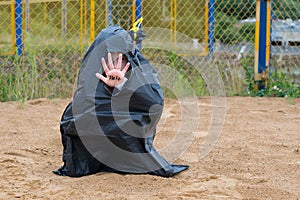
[215,0,300,44]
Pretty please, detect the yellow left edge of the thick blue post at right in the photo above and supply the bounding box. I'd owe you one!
[254,0,261,81]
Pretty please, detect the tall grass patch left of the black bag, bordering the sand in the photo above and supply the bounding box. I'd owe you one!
[0,48,80,101]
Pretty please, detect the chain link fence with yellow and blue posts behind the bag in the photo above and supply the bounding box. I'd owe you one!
[0,0,300,101]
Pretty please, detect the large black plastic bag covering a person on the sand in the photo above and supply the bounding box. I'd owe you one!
[54,26,188,177]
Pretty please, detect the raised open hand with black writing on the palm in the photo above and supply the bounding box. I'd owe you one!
[96,53,130,87]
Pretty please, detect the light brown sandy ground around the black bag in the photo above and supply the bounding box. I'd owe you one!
[0,97,300,200]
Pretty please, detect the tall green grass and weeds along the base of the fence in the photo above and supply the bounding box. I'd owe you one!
[0,18,300,101]
